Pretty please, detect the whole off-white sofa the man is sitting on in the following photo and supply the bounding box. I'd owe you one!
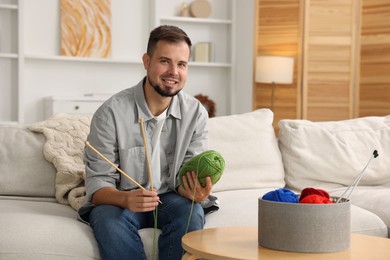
[0,109,390,259]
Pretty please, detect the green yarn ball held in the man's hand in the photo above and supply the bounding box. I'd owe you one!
[179,150,225,188]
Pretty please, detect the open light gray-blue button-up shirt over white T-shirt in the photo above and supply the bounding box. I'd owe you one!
[79,78,208,216]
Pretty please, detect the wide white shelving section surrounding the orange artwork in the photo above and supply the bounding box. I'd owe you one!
[17,0,149,122]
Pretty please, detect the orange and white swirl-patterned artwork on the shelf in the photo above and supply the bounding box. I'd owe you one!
[61,0,111,58]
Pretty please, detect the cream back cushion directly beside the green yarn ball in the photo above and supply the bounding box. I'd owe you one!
[209,109,285,192]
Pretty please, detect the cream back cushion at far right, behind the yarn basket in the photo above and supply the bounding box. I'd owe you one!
[278,116,390,191]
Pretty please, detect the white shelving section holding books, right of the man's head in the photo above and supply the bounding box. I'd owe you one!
[150,0,236,115]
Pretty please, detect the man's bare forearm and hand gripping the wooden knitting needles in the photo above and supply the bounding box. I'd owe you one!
[92,187,160,212]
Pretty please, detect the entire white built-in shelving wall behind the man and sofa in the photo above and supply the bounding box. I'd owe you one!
[0,0,253,123]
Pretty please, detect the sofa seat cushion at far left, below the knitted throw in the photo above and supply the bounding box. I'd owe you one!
[0,198,100,259]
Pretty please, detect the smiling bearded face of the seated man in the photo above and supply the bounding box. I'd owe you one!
[143,41,190,97]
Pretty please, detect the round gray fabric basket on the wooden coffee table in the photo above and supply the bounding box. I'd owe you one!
[258,197,351,253]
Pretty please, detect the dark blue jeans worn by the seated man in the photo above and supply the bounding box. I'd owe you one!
[89,192,205,260]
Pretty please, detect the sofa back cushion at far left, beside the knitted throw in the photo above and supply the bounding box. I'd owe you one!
[0,126,56,197]
